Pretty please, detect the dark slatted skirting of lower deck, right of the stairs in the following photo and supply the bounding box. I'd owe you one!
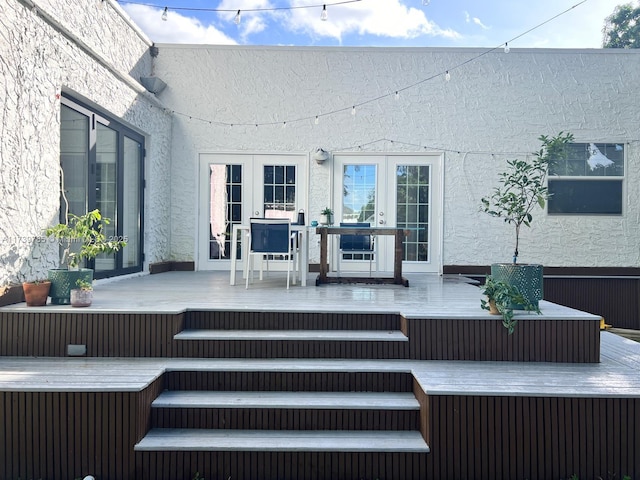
[425,396,640,480]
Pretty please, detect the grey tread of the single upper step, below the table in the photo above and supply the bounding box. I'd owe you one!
[173,329,409,342]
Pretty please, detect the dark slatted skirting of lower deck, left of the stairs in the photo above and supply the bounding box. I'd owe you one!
[0,380,162,480]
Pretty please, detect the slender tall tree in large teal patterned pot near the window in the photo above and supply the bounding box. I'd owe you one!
[481,132,573,309]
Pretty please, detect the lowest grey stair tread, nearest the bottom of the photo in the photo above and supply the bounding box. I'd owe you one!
[135,428,429,453]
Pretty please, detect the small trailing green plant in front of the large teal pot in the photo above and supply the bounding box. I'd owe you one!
[480,275,541,335]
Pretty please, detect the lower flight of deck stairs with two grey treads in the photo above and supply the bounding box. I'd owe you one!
[135,369,429,478]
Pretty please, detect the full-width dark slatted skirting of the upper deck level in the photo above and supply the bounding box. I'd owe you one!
[0,311,600,363]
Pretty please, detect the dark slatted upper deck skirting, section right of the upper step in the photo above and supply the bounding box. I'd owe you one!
[403,318,600,363]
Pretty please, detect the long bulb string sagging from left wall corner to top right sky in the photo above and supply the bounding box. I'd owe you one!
[156,0,588,131]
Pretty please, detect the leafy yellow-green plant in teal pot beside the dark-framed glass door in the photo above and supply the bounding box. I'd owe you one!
[45,209,126,305]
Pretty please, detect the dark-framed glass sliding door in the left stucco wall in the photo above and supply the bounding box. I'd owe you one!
[60,96,144,278]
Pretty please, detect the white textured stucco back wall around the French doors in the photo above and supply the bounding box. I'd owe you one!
[155,44,640,266]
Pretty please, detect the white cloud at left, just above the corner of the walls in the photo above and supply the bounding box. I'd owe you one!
[122,4,237,45]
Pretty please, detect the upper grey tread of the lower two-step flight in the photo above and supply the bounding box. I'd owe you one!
[152,390,420,410]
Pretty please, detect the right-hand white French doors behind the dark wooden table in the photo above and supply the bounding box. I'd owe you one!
[331,154,442,273]
